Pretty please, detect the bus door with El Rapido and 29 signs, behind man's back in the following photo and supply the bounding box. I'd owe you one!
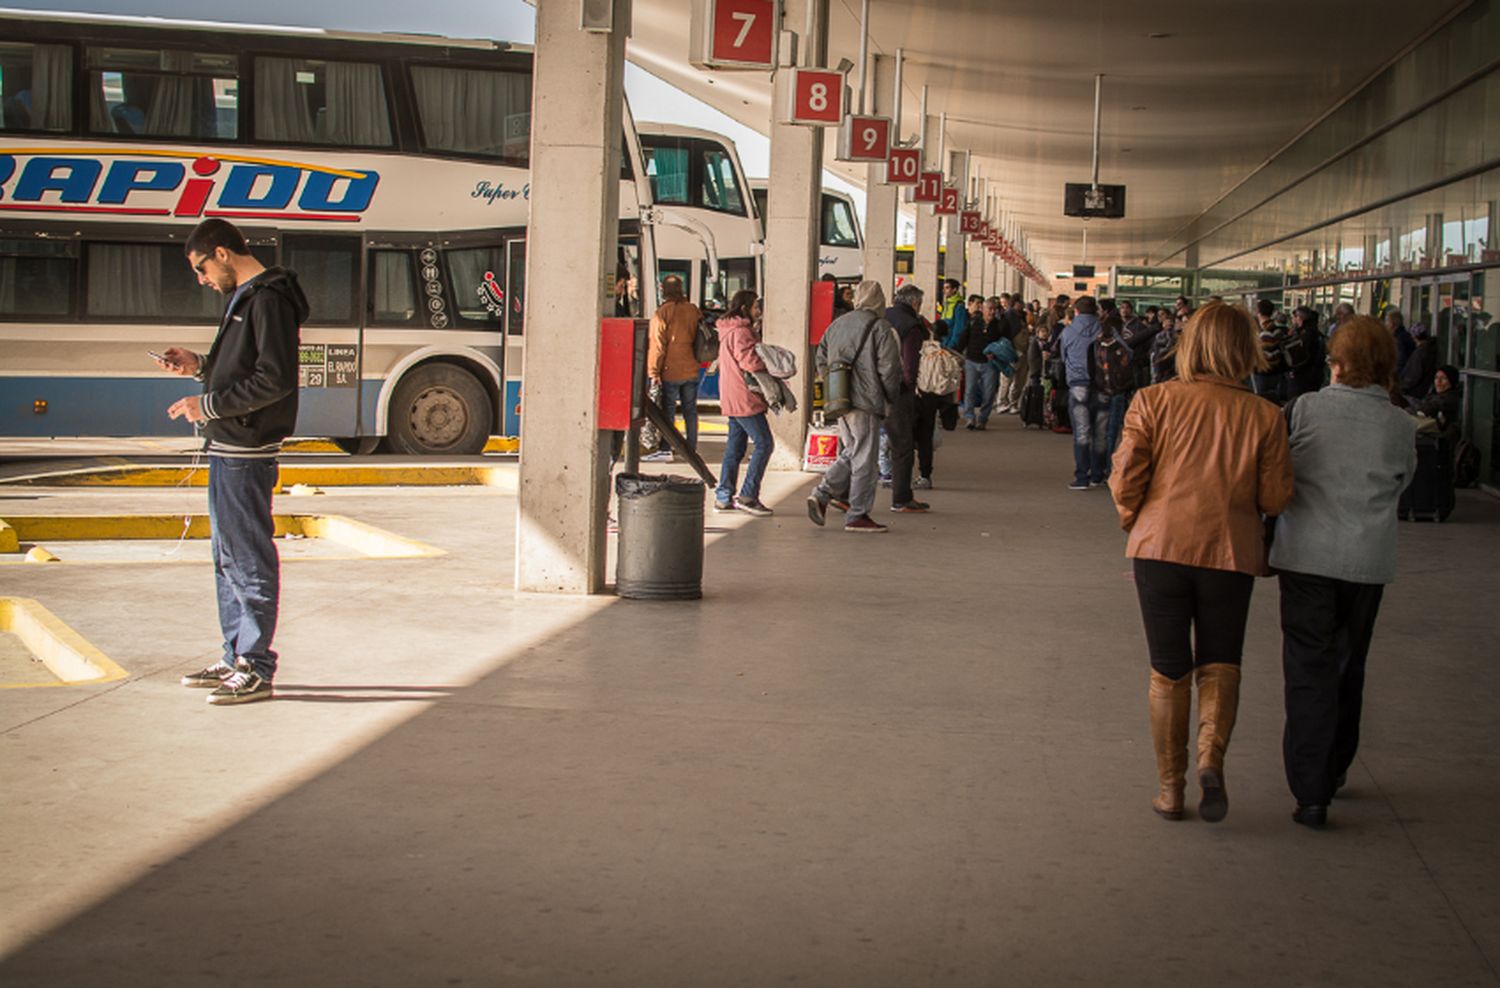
[281,231,368,439]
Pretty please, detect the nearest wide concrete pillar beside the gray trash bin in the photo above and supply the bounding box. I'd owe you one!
[516,0,630,594]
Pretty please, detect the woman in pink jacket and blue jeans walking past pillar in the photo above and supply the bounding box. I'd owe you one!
[714,289,776,517]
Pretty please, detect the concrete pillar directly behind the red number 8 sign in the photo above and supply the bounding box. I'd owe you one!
[764,0,834,469]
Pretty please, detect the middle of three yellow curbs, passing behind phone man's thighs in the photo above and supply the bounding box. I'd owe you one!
[0,514,446,565]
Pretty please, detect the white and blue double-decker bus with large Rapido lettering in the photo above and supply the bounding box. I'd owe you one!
[0,12,656,454]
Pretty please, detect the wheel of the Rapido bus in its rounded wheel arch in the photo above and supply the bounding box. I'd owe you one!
[386,364,494,456]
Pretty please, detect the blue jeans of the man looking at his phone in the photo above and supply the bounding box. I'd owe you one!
[209,456,281,679]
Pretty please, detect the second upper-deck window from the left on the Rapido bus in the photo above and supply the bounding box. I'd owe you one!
[89,48,240,141]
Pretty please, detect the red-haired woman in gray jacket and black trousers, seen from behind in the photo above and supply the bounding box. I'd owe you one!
[1271,316,1416,828]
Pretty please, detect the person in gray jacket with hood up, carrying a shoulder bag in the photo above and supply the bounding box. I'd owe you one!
[807,280,902,532]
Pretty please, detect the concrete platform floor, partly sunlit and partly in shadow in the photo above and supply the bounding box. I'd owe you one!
[0,417,1500,987]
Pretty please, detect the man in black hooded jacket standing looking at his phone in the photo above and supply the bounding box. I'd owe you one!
[156,219,308,705]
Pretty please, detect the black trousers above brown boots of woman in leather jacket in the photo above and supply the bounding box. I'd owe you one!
[1136,559,1256,679]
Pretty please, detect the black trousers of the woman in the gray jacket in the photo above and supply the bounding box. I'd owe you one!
[1278,573,1385,805]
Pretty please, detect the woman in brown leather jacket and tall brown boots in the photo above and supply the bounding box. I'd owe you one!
[1110,301,1292,822]
